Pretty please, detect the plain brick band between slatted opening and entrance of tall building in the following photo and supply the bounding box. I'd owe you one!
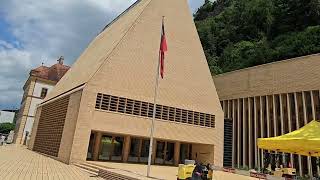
[91,111,217,144]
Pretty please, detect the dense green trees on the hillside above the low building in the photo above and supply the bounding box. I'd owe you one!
[194,0,320,74]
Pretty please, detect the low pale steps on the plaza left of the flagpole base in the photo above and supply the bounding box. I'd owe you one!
[73,162,144,180]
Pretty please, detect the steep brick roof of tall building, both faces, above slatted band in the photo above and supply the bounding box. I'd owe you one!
[47,0,222,114]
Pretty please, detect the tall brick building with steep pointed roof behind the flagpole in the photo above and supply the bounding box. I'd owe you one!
[29,0,223,166]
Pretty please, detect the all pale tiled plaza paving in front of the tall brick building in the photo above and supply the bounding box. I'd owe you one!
[0,145,254,180]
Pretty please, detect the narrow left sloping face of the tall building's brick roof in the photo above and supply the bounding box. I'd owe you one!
[45,0,151,101]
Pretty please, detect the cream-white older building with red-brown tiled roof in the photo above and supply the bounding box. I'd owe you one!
[14,57,70,144]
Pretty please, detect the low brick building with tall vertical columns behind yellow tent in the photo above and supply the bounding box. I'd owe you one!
[214,54,320,176]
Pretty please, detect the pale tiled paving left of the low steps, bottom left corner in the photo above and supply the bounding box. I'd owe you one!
[0,145,101,180]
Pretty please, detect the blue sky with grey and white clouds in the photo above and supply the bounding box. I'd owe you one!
[0,0,204,109]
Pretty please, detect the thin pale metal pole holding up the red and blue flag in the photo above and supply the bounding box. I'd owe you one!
[147,16,164,177]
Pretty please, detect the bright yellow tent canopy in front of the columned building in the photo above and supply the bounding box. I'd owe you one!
[258,120,320,157]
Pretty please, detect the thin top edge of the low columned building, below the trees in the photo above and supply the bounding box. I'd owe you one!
[213,53,320,77]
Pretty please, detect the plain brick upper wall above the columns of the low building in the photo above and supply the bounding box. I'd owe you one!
[214,54,320,100]
